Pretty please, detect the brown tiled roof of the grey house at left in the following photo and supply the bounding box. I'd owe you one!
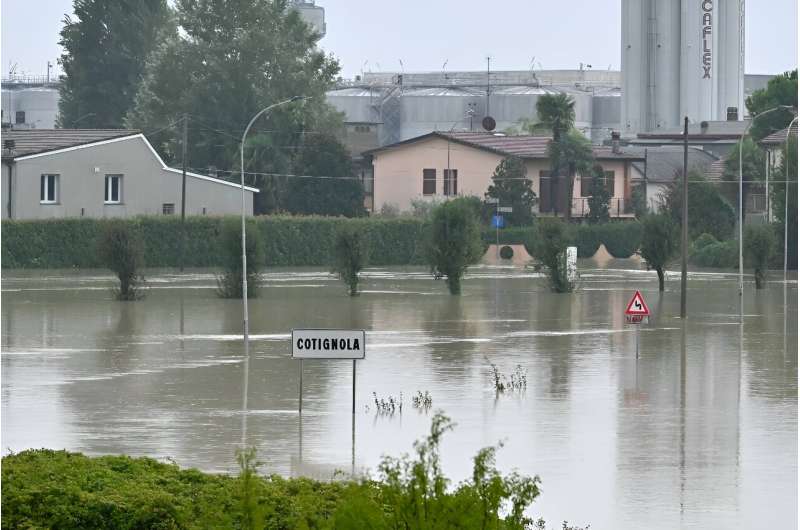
[2,129,139,158]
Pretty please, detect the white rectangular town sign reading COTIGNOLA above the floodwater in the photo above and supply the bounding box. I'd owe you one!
[292,329,366,359]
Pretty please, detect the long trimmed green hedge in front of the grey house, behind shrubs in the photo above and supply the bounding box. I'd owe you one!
[1,216,422,268]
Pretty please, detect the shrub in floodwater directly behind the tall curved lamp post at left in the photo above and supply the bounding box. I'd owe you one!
[217,218,264,298]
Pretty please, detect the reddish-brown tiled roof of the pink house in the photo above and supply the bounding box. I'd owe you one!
[365,132,644,160]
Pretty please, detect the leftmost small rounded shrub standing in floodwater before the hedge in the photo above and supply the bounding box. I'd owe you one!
[98,221,144,300]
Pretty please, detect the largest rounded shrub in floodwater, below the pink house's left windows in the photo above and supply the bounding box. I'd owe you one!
[425,198,483,294]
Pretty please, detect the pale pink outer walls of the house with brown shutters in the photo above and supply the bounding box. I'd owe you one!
[372,138,630,215]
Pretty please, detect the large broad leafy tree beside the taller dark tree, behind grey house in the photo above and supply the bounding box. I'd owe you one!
[126,0,342,213]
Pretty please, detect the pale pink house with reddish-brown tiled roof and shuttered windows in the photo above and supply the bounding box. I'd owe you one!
[364,132,644,218]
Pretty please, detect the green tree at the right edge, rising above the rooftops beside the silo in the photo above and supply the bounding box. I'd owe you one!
[745,69,797,141]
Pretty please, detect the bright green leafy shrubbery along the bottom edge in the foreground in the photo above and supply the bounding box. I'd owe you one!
[2,413,564,530]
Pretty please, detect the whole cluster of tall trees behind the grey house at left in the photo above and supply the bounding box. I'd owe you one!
[58,0,366,217]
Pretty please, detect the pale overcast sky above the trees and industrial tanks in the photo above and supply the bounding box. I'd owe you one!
[0,0,797,77]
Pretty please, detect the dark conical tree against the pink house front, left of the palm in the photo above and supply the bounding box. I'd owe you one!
[486,157,537,226]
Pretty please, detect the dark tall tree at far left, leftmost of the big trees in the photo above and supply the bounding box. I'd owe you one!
[58,0,172,129]
